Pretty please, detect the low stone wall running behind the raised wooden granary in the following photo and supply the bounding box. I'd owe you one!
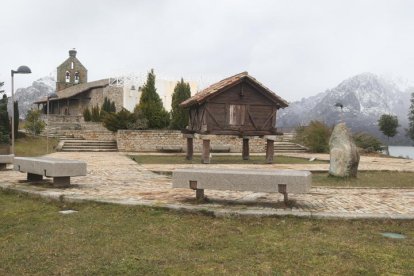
[117,130,272,152]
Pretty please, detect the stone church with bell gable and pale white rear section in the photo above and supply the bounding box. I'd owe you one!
[34,49,197,122]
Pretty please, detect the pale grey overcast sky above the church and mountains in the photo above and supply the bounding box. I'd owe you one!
[0,0,414,101]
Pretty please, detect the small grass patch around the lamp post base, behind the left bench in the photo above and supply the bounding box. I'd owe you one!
[14,136,58,156]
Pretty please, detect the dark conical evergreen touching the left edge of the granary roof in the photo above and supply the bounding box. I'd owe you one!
[170,78,191,129]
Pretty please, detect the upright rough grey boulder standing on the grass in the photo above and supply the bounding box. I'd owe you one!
[329,123,359,177]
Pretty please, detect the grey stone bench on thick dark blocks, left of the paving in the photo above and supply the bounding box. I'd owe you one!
[14,157,86,188]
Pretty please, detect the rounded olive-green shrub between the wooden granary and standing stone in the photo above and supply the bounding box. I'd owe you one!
[296,121,332,152]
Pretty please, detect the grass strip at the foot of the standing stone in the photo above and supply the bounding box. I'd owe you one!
[312,171,414,188]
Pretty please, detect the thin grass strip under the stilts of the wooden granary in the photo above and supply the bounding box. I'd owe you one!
[130,154,328,164]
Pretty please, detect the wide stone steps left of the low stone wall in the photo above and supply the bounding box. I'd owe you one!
[58,139,118,152]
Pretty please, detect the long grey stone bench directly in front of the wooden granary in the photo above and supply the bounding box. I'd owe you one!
[172,169,312,203]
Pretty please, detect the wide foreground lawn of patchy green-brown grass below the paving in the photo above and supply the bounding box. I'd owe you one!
[0,192,414,275]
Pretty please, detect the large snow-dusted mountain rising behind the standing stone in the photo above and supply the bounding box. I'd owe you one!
[277,73,413,144]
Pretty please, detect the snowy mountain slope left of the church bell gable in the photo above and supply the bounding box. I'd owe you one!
[8,75,56,119]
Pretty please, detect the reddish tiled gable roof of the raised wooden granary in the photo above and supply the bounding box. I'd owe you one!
[180,72,289,108]
